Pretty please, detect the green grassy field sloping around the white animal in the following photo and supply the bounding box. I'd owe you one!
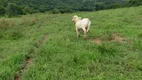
[0,6,142,80]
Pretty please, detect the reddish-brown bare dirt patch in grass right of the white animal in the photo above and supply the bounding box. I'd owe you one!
[89,33,126,45]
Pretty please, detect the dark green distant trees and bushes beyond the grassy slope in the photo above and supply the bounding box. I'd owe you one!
[0,0,142,16]
